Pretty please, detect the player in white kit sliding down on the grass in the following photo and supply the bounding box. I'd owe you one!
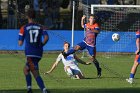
[44,42,90,79]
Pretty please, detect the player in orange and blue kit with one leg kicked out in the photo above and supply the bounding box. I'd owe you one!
[62,15,101,77]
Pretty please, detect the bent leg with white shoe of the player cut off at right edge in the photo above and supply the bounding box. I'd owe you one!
[126,55,140,84]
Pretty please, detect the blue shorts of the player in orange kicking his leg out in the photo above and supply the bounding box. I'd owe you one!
[77,42,96,56]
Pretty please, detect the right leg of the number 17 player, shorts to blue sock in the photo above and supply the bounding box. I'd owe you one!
[28,57,47,93]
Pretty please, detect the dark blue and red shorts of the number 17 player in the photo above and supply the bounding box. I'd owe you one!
[26,57,41,71]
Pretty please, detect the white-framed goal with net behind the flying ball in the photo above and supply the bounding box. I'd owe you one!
[91,5,140,53]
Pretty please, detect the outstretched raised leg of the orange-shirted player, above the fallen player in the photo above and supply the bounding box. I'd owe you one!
[62,42,86,57]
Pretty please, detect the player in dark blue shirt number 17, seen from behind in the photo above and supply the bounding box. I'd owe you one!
[18,9,48,93]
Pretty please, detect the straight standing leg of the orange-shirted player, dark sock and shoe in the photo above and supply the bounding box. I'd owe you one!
[87,46,102,77]
